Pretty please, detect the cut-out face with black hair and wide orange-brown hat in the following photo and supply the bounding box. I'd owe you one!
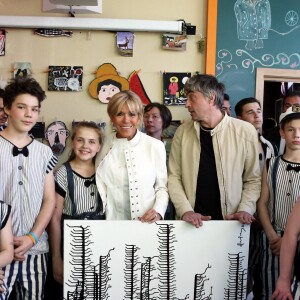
[89,63,129,104]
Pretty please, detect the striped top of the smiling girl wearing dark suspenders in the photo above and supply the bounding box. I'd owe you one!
[55,165,98,215]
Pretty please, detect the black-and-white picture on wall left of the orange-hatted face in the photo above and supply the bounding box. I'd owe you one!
[48,66,83,92]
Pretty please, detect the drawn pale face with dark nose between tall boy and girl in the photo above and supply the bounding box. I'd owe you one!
[45,122,69,155]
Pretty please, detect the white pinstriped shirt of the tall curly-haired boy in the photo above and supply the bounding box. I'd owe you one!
[0,136,57,254]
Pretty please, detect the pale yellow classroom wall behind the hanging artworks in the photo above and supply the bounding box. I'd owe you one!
[0,0,207,163]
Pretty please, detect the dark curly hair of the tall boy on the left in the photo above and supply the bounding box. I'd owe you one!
[3,77,46,109]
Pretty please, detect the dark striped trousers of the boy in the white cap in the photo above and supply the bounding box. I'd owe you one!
[261,231,284,300]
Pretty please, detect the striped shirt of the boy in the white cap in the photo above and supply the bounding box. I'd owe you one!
[268,157,300,231]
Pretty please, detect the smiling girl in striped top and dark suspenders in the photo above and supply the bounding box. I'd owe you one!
[49,121,103,299]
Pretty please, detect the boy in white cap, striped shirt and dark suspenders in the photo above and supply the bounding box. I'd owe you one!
[258,105,300,300]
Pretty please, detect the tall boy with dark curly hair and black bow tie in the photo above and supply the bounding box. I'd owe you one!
[0,77,57,300]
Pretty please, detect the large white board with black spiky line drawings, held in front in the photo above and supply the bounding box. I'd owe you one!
[64,220,250,300]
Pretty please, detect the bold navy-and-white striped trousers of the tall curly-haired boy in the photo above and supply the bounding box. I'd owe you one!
[0,253,48,300]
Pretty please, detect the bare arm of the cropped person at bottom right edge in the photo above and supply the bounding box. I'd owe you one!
[272,198,300,300]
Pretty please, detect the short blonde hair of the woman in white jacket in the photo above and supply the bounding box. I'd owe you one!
[107,90,144,120]
